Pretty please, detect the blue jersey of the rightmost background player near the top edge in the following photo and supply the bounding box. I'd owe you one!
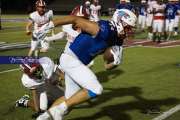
[165,3,178,19]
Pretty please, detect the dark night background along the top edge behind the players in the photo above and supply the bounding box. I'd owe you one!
[0,0,140,14]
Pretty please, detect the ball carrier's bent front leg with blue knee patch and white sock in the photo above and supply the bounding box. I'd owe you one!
[39,55,102,119]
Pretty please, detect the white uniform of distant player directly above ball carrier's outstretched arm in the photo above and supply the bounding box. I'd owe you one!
[90,4,101,22]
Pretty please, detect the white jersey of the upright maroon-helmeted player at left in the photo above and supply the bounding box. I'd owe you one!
[29,10,53,30]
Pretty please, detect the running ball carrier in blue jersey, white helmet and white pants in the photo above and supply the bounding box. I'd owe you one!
[37,9,137,120]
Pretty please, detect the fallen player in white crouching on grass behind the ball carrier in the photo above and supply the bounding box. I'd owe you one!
[16,57,63,115]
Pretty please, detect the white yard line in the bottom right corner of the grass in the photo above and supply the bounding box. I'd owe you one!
[152,104,180,120]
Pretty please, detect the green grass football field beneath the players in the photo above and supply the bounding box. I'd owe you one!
[0,15,180,120]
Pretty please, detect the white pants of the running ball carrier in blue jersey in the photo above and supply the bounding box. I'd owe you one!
[60,54,102,99]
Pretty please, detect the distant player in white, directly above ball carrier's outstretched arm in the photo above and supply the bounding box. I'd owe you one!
[90,0,101,22]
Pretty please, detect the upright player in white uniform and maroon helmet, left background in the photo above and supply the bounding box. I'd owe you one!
[26,0,53,57]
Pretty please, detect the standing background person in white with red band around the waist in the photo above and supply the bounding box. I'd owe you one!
[153,0,166,43]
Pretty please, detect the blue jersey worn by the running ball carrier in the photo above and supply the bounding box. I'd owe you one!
[70,20,119,65]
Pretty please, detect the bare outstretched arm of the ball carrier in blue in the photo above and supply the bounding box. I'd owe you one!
[53,16,99,36]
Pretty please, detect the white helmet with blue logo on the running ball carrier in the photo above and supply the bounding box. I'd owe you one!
[112,9,137,27]
